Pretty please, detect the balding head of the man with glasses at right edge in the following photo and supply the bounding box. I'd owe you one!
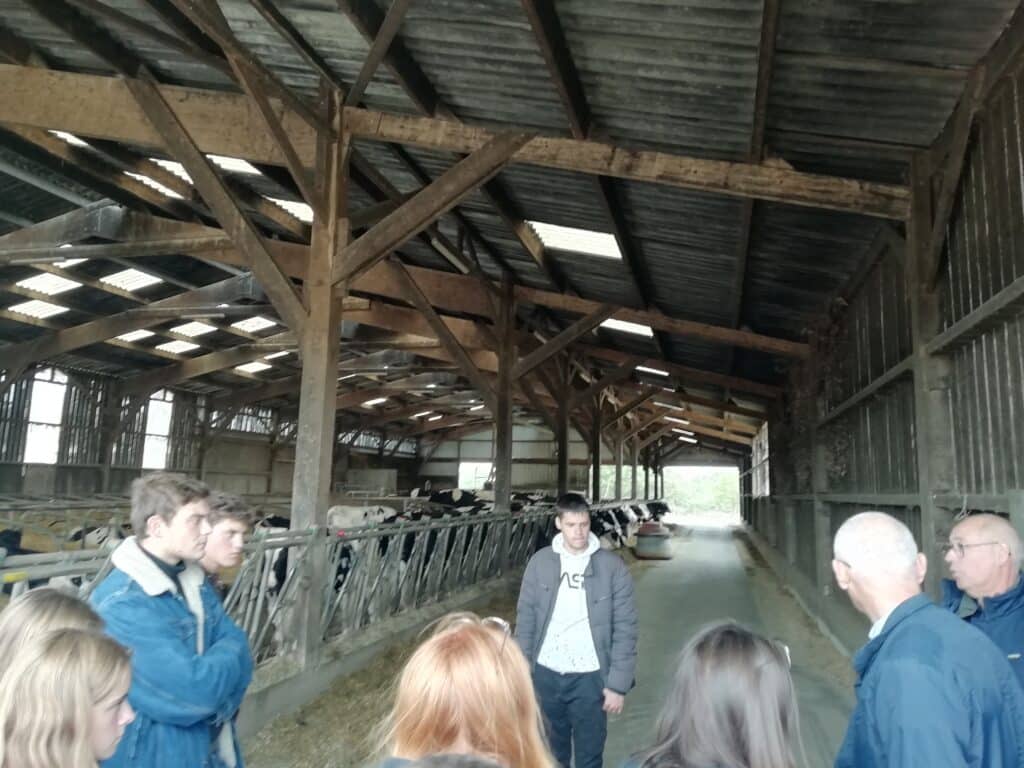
[945,514,1022,600]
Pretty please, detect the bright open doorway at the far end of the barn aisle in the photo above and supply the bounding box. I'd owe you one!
[664,466,740,527]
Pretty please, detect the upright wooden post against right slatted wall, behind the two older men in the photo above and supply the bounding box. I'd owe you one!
[906,154,953,596]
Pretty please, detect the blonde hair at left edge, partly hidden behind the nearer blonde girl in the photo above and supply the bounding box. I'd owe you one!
[0,587,103,675]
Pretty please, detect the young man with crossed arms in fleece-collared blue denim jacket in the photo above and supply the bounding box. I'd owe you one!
[90,472,252,768]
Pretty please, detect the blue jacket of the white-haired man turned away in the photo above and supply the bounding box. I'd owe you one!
[836,595,1024,768]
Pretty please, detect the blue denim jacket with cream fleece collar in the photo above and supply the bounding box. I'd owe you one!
[90,538,253,768]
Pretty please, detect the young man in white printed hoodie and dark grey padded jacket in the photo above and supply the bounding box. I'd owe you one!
[515,494,637,768]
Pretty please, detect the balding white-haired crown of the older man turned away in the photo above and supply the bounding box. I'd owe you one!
[833,512,918,579]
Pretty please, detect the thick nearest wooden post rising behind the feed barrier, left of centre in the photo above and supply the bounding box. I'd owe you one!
[292,89,350,668]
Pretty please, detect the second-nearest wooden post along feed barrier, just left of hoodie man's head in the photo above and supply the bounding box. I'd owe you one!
[495,275,516,573]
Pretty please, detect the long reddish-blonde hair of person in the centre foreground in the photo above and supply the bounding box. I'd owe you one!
[383,613,555,768]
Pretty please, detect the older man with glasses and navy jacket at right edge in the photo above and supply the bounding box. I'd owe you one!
[942,514,1024,686]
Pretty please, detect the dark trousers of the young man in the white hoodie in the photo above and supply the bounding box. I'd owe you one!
[534,665,608,768]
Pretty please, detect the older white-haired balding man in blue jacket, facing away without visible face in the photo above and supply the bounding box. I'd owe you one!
[833,512,1024,768]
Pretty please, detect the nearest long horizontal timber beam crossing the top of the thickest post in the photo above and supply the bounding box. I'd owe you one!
[0,65,908,219]
